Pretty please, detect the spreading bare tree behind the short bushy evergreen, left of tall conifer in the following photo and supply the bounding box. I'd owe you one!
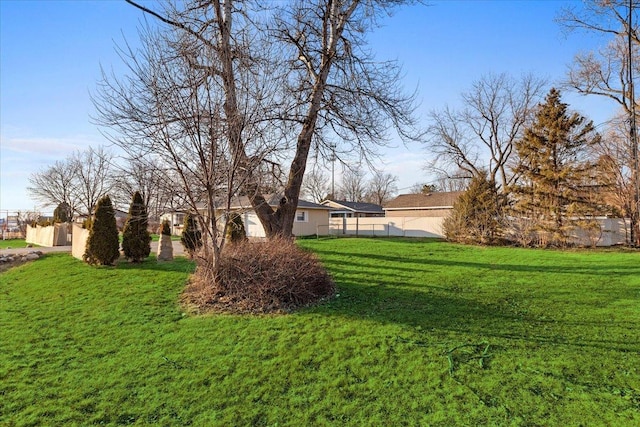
[428,73,546,189]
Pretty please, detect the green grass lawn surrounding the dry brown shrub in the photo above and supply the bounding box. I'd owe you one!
[0,239,640,426]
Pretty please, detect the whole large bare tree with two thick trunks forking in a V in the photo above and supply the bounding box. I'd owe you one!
[110,0,417,241]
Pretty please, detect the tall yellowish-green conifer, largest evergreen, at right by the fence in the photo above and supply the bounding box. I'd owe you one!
[514,89,600,245]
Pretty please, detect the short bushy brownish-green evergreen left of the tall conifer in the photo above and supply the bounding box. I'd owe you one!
[442,172,503,244]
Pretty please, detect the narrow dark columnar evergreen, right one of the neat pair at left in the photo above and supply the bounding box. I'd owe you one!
[122,191,151,262]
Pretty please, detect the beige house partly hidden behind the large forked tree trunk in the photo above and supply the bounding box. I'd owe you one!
[161,195,332,237]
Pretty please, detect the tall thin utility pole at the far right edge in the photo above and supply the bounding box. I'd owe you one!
[627,0,640,246]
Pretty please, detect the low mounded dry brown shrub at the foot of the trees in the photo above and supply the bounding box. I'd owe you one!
[183,239,335,313]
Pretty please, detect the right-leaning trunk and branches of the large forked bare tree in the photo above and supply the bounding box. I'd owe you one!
[252,0,424,236]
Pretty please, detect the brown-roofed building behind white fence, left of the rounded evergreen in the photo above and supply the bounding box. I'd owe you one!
[384,191,464,217]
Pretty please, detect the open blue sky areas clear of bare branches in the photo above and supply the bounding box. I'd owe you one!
[0,0,615,217]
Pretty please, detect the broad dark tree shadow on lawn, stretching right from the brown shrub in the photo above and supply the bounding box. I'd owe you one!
[317,281,640,352]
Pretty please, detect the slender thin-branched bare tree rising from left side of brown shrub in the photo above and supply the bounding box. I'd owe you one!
[94,11,254,269]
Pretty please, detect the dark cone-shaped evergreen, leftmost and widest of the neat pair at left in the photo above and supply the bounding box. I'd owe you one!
[83,196,120,265]
